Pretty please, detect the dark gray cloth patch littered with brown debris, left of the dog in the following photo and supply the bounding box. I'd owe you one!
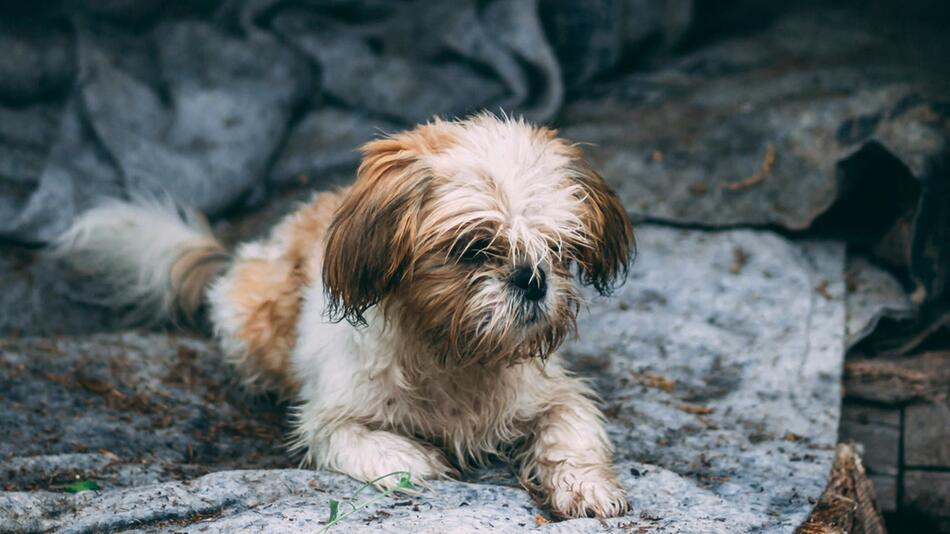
[0,332,288,490]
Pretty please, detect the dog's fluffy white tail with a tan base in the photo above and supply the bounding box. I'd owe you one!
[52,199,231,321]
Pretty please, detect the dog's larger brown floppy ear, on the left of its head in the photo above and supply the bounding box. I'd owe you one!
[323,132,432,324]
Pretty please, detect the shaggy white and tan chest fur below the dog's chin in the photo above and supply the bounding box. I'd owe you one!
[295,304,541,462]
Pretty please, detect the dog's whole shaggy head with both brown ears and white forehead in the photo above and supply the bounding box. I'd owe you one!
[324,115,634,364]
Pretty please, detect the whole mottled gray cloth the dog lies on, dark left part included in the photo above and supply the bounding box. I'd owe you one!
[0,226,845,533]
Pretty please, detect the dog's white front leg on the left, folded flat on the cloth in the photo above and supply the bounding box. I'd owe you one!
[308,423,454,489]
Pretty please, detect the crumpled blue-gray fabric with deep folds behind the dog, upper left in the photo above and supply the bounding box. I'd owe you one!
[0,0,691,244]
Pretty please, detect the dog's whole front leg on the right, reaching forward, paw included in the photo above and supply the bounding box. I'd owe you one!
[521,375,628,517]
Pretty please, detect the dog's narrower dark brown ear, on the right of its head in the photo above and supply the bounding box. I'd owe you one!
[572,153,636,295]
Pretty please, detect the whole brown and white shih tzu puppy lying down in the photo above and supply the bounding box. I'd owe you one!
[57,114,634,517]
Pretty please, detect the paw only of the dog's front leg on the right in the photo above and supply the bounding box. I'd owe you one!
[545,467,629,518]
